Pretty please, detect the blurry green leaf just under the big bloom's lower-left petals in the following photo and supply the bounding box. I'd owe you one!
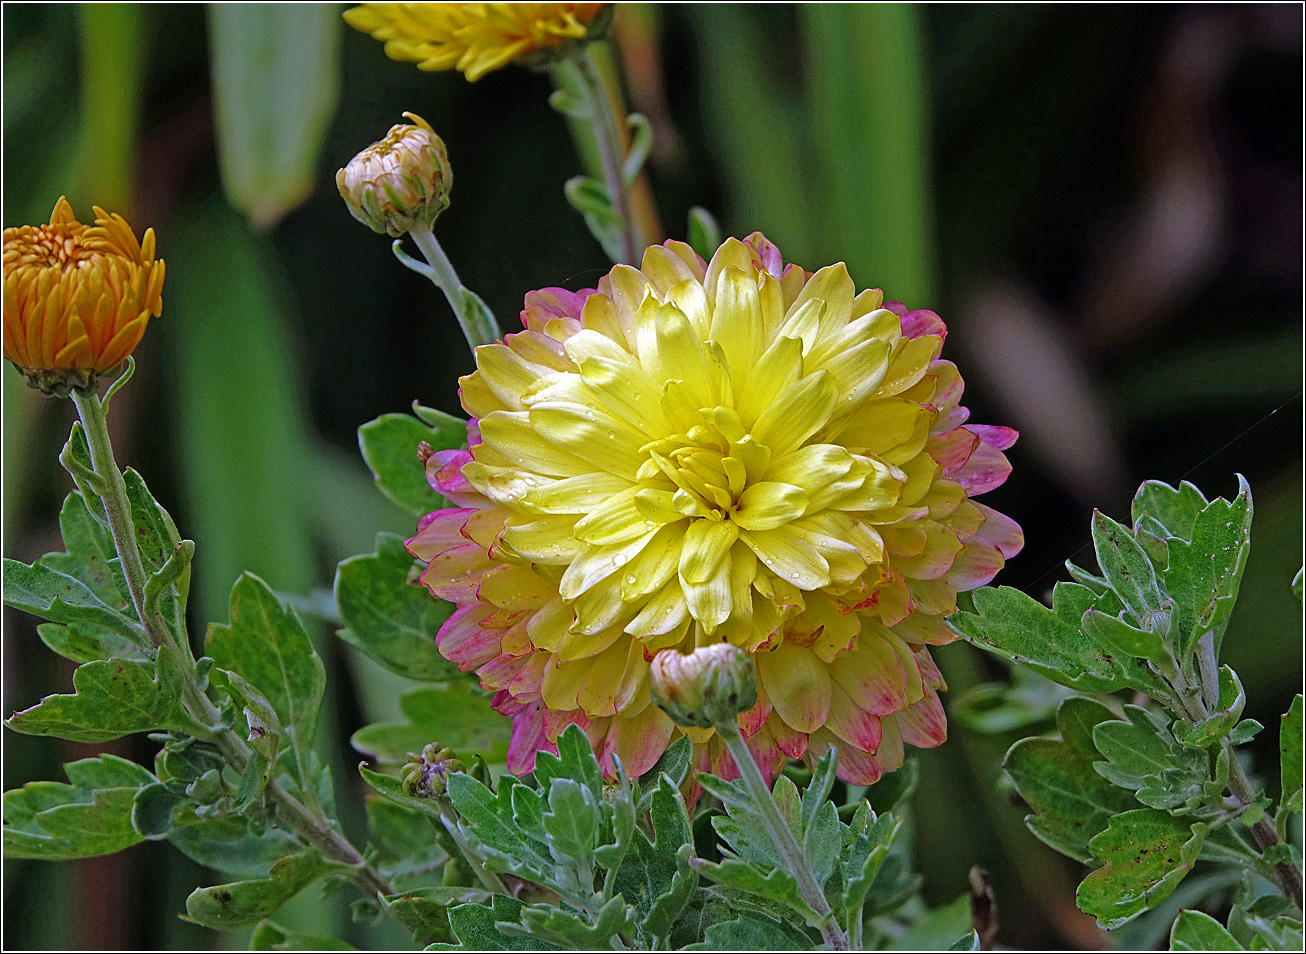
[350,682,512,765]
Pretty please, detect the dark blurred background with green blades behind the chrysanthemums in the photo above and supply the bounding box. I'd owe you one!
[3,4,1302,949]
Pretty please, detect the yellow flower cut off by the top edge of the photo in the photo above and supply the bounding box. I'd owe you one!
[345,4,605,81]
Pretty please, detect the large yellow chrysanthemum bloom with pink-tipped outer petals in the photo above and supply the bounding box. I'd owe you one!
[409,234,1023,784]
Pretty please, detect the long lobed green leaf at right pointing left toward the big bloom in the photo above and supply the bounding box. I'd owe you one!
[948,583,1158,693]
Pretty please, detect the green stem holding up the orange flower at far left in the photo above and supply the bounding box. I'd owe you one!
[72,378,394,894]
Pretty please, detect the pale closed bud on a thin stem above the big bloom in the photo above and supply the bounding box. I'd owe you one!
[336,112,453,238]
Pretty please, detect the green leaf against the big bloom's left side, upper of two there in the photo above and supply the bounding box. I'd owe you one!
[358,414,468,516]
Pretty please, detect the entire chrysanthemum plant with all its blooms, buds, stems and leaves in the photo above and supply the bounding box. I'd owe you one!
[4,4,1302,950]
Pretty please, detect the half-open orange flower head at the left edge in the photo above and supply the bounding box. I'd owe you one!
[4,197,165,393]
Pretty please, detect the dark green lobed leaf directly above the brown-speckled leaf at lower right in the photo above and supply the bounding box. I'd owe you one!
[1003,697,1138,863]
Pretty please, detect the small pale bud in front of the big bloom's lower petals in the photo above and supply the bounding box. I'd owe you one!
[649,643,757,728]
